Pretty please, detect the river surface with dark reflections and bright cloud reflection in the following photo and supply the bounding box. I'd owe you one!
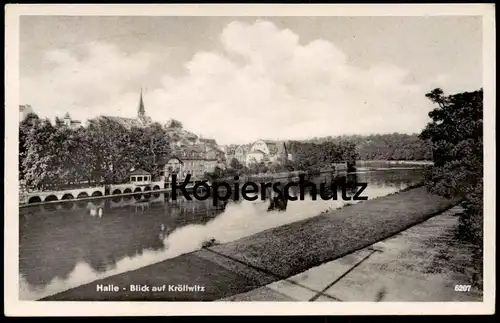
[19,169,423,300]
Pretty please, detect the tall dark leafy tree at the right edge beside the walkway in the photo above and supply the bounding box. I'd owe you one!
[420,89,483,243]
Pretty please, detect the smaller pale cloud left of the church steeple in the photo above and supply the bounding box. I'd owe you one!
[20,43,150,118]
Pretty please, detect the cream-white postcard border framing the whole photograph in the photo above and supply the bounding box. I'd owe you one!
[4,4,496,316]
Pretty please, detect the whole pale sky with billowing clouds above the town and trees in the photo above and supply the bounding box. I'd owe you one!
[19,16,482,144]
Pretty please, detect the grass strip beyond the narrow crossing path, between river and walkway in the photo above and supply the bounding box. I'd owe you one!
[210,187,458,277]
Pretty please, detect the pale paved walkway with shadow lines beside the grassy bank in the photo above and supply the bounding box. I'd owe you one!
[219,207,482,302]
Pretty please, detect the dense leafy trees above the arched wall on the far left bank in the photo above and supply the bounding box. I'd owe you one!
[19,113,169,190]
